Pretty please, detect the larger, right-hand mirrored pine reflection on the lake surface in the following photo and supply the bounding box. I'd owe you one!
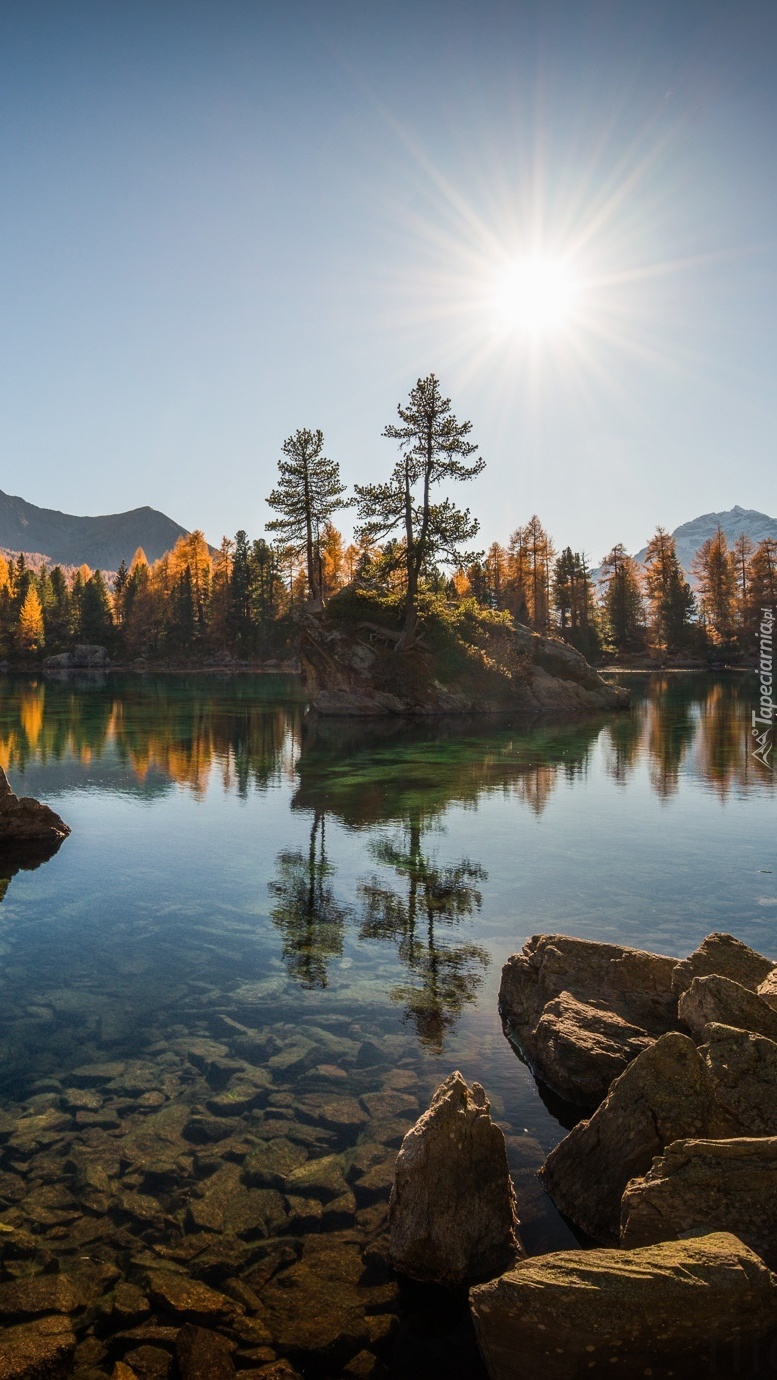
[359,816,489,1053]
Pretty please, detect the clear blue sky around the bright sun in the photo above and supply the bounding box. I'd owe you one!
[0,0,777,560]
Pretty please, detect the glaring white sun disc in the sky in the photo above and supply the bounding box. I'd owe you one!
[494,255,580,335]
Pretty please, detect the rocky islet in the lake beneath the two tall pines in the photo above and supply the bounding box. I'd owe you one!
[297,611,629,715]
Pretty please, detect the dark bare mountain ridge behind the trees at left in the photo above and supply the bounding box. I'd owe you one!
[0,489,186,570]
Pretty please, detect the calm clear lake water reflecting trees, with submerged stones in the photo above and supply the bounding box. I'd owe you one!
[0,672,777,1377]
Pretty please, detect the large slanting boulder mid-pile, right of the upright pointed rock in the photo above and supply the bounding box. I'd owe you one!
[540,1031,736,1245]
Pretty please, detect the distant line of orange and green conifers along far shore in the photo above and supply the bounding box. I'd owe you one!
[0,516,777,661]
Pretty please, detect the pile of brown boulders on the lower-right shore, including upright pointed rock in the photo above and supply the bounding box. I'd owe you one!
[389,934,777,1380]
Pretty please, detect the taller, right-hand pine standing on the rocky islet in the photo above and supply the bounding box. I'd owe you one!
[355,374,486,640]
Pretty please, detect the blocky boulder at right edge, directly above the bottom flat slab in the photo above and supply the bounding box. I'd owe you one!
[621,1136,777,1268]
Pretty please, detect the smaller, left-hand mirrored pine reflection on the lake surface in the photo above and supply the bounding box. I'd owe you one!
[268,810,351,988]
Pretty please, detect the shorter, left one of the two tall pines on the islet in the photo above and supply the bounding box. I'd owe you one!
[266,428,349,609]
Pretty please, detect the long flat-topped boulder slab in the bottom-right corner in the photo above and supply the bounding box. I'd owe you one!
[469,1232,777,1380]
